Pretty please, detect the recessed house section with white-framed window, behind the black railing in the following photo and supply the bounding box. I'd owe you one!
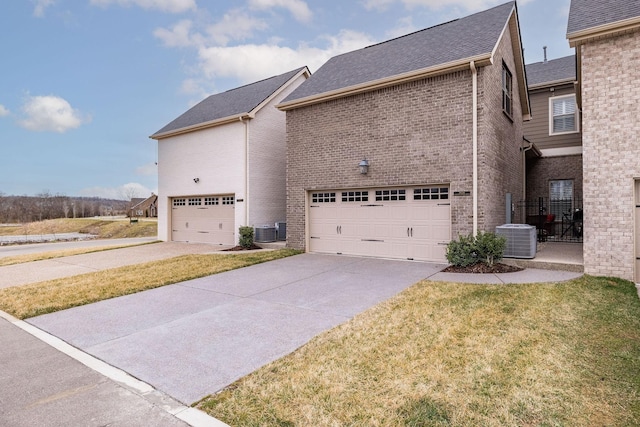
[517,55,582,237]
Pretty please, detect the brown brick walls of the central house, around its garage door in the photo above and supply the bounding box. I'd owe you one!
[287,33,523,249]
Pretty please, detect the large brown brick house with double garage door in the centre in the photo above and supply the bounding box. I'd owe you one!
[278,2,530,261]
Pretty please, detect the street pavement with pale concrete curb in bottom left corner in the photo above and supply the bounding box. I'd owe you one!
[0,312,224,427]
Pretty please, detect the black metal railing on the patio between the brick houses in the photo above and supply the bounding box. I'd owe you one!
[513,197,584,243]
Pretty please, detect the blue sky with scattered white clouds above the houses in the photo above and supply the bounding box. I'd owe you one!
[0,0,574,200]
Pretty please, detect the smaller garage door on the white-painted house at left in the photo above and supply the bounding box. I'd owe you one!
[171,195,235,245]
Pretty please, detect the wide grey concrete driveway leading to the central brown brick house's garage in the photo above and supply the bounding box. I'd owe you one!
[29,254,445,404]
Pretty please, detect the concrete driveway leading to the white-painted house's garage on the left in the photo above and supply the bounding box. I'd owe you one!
[0,241,228,289]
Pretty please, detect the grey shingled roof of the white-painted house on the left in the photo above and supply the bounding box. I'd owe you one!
[150,67,308,139]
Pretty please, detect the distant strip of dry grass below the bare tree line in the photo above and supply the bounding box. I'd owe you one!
[0,218,158,239]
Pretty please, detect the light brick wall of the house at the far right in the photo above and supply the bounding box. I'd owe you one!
[581,30,640,280]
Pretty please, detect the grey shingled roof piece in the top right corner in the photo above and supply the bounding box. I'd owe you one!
[567,0,640,38]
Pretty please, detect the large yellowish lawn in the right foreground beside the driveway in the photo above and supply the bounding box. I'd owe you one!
[197,276,640,427]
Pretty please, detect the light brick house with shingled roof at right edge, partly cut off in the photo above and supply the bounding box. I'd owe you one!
[567,0,640,282]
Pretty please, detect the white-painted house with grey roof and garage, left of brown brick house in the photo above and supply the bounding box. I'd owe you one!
[151,67,309,245]
